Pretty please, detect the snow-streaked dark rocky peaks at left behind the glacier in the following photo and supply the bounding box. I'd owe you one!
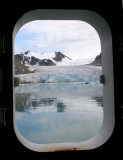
[15,51,72,66]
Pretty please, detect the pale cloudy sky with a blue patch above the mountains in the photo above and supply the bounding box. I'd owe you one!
[14,20,101,63]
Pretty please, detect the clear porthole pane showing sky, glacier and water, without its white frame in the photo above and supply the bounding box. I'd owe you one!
[14,20,103,144]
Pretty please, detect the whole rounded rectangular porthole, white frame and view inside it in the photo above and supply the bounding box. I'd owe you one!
[13,9,114,152]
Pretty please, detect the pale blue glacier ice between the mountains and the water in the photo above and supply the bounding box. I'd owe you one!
[15,65,102,84]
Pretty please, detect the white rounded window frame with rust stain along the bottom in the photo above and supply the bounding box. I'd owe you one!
[13,9,115,152]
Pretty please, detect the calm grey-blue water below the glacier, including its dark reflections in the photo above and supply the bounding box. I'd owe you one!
[15,65,103,144]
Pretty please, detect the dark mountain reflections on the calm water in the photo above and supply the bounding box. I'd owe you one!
[16,94,103,112]
